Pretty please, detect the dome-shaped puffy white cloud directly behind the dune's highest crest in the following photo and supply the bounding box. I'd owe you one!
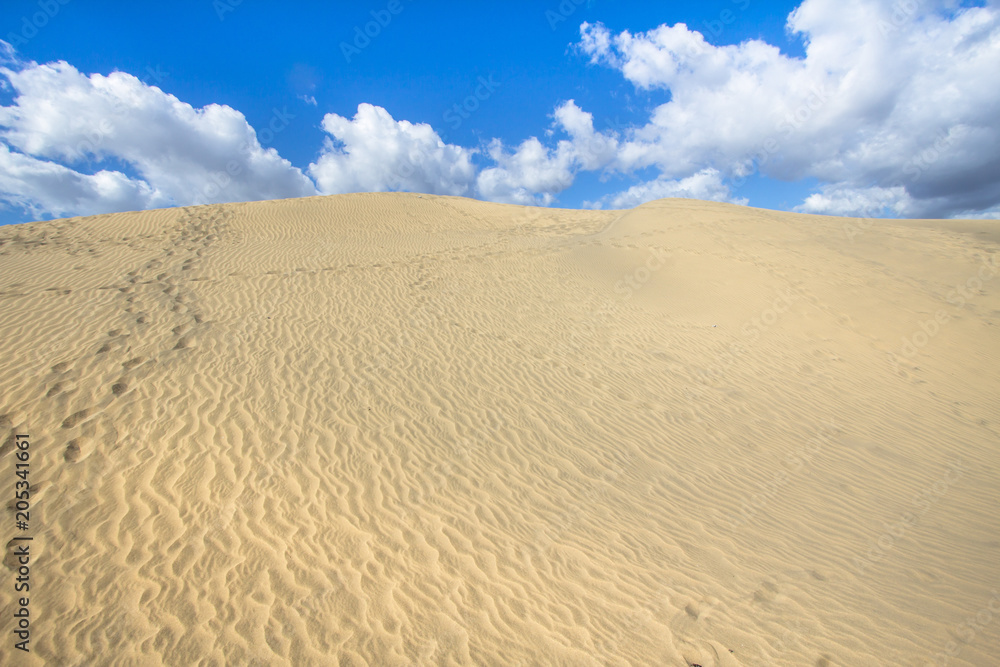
[309,104,476,195]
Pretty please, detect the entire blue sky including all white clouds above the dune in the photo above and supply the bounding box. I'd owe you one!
[0,0,1000,223]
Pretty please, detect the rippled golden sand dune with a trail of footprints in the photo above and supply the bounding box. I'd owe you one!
[0,193,1000,667]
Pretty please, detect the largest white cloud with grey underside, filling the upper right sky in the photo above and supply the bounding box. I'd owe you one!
[579,0,1000,217]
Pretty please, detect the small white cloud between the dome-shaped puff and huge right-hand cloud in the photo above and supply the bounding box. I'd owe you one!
[477,100,618,206]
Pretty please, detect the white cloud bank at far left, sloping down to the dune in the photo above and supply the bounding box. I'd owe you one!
[0,52,316,215]
